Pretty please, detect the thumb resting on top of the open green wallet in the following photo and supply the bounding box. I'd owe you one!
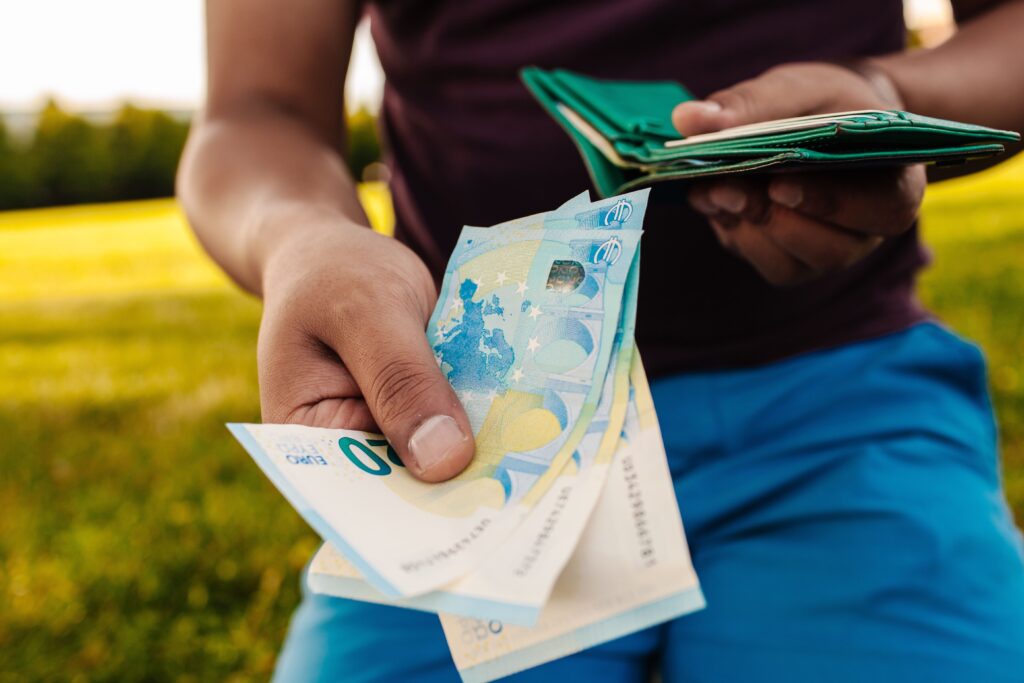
[672,70,821,136]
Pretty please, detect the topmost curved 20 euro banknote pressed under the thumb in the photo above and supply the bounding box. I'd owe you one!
[229,190,647,596]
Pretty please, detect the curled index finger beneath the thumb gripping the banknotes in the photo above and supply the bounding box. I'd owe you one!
[257,328,378,431]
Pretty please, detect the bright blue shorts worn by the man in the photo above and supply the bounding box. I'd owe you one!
[275,324,1024,683]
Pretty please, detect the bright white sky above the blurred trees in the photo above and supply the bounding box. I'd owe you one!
[0,0,949,111]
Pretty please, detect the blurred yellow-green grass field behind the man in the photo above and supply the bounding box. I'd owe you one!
[0,172,1024,681]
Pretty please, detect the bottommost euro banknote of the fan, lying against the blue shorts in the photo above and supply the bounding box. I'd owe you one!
[440,356,705,683]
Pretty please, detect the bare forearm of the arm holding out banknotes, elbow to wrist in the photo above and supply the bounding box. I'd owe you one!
[178,108,368,294]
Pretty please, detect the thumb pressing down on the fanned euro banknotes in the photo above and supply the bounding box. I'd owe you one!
[325,293,474,481]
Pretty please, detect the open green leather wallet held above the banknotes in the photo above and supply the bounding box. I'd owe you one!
[520,67,1020,197]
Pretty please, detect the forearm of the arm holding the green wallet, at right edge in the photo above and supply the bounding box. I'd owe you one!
[872,0,1024,130]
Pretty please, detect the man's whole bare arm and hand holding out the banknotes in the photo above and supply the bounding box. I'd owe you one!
[178,0,474,481]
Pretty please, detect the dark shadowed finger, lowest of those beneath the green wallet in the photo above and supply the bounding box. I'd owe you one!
[762,207,882,273]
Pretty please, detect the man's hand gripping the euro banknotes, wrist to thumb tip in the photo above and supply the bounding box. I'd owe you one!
[259,212,474,481]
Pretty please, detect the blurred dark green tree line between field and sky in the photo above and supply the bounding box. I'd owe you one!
[0,101,380,211]
